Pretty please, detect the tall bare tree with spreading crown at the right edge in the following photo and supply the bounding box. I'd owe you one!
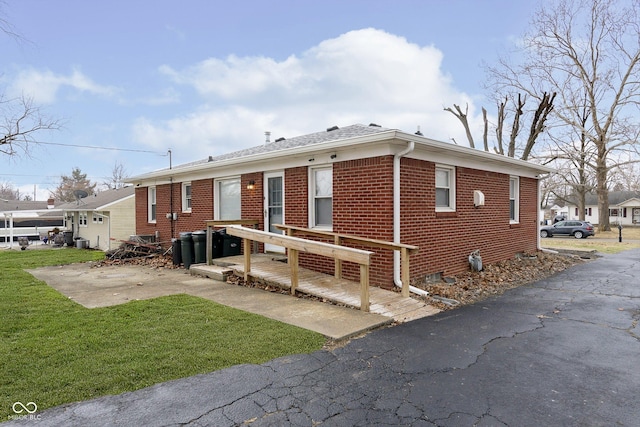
[489,0,640,230]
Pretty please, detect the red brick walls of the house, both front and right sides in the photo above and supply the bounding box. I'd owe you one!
[136,156,538,288]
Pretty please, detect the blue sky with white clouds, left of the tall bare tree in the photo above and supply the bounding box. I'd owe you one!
[0,0,536,200]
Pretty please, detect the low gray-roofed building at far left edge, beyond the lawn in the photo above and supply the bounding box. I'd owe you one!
[0,199,63,246]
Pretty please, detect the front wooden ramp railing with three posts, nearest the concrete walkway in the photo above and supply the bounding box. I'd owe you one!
[227,225,373,311]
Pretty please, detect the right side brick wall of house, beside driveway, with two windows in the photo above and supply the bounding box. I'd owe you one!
[401,159,538,280]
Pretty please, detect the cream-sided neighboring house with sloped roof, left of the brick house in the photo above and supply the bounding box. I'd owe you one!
[58,186,136,251]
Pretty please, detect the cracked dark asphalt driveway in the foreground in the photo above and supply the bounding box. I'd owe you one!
[7,250,640,426]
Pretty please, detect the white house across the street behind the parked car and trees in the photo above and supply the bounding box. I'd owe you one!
[567,191,640,226]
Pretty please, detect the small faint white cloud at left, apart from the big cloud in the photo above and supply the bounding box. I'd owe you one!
[9,68,118,104]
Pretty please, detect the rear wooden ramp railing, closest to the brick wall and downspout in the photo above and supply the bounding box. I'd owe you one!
[274,224,419,298]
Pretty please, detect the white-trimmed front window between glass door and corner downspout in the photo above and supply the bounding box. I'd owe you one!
[309,166,333,229]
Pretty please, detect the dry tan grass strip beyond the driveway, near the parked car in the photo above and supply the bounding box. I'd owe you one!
[540,225,640,254]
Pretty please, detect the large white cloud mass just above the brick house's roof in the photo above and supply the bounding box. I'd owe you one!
[133,29,481,160]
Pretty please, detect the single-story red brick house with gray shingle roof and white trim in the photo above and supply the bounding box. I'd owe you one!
[128,124,552,288]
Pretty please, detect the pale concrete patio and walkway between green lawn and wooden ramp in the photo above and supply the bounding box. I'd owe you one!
[28,263,393,340]
